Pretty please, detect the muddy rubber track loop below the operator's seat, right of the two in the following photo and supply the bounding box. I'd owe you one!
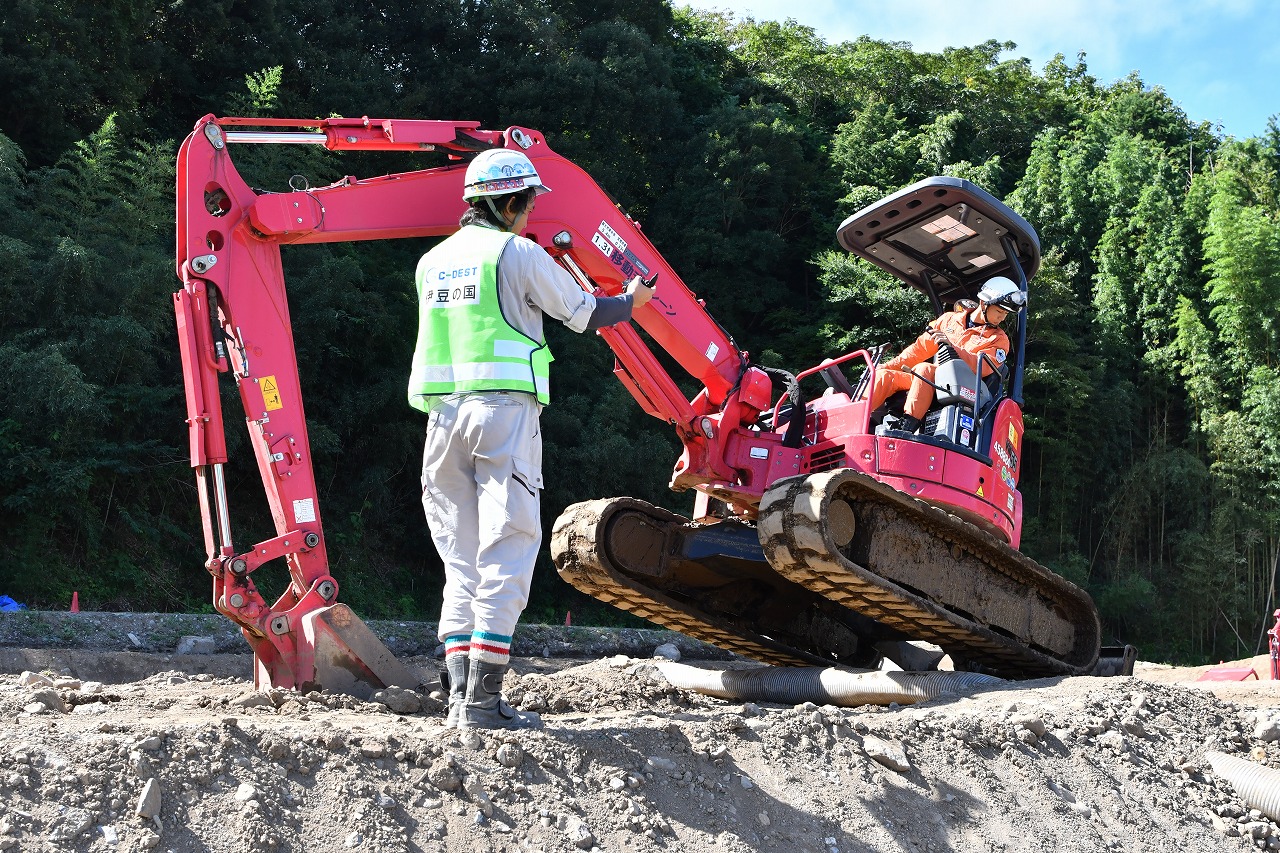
[758,469,1101,678]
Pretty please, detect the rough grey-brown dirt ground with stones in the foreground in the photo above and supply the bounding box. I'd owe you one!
[0,627,1280,853]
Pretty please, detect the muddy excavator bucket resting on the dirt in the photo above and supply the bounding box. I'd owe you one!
[256,596,422,699]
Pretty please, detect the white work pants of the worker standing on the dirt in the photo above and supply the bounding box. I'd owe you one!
[422,392,543,642]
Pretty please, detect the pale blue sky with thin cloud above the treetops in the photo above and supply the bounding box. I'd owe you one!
[673,0,1280,138]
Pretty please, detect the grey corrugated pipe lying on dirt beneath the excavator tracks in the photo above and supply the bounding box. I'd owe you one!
[657,661,1004,708]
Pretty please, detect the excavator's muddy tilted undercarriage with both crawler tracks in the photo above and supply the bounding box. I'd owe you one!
[552,469,1112,678]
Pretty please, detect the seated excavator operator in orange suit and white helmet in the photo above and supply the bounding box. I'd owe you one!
[870,275,1027,433]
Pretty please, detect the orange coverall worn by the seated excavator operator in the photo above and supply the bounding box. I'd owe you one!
[870,307,1009,419]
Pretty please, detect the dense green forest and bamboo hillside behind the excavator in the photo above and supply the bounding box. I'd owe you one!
[0,0,1280,661]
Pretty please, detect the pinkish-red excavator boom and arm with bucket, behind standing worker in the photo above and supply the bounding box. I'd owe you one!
[174,115,771,694]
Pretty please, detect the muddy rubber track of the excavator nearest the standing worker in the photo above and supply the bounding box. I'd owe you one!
[552,498,831,666]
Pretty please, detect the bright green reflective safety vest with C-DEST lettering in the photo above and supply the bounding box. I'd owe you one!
[408,225,552,411]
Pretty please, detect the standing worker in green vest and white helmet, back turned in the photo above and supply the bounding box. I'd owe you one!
[408,149,653,729]
